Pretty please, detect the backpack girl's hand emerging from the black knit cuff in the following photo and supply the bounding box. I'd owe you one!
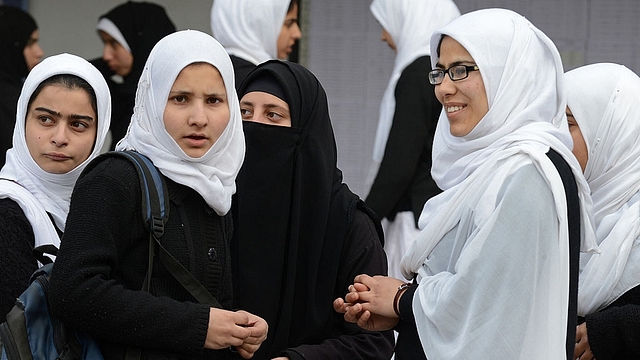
[204,308,251,349]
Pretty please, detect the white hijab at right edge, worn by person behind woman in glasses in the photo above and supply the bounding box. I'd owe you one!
[566,63,640,316]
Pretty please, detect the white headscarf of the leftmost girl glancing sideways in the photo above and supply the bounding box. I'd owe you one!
[0,54,111,246]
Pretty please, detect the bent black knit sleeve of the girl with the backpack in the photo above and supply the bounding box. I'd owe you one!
[49,158,209,353]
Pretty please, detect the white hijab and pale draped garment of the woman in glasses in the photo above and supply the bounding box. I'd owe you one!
[402,9,597,359]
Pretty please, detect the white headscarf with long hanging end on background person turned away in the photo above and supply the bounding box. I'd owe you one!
[370,0,460,163]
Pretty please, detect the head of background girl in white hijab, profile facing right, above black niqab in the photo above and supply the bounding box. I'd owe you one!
[211,0,302,87]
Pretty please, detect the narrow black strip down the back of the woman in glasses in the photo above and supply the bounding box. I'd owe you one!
[547,149,580,359]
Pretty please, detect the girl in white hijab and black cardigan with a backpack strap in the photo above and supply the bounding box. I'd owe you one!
[49,30,267,359]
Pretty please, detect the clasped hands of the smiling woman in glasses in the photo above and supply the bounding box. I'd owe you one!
[333,274,403,331]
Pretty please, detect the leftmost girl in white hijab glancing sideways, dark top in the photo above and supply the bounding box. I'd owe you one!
[0,54,111,322]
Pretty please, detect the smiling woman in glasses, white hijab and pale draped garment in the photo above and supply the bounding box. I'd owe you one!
[334,9,595,359]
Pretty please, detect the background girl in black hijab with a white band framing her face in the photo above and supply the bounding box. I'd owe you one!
[91,1,176,150]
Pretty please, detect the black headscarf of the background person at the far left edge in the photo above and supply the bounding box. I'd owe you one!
[0,5,38,167]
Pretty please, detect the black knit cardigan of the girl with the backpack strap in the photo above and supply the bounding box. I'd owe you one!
[49,157,233,359]
